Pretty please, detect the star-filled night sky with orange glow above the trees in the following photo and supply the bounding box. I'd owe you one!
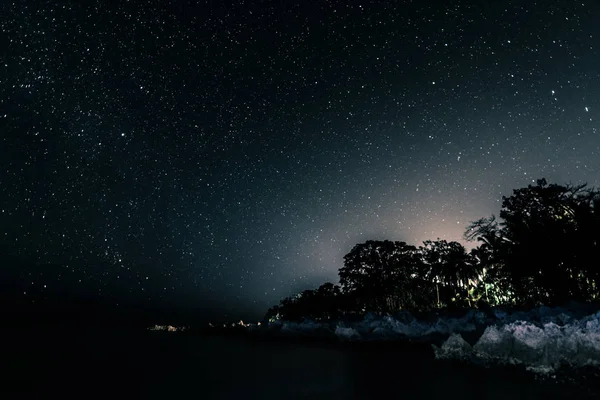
[0,0,600,316]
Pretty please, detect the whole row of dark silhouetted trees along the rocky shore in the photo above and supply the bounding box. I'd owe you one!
[266,179,600,320]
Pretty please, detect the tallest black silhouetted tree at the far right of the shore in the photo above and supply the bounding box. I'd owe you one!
[500,179,600,304]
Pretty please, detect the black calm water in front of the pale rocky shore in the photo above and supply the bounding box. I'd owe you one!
[0,329,600,400]
